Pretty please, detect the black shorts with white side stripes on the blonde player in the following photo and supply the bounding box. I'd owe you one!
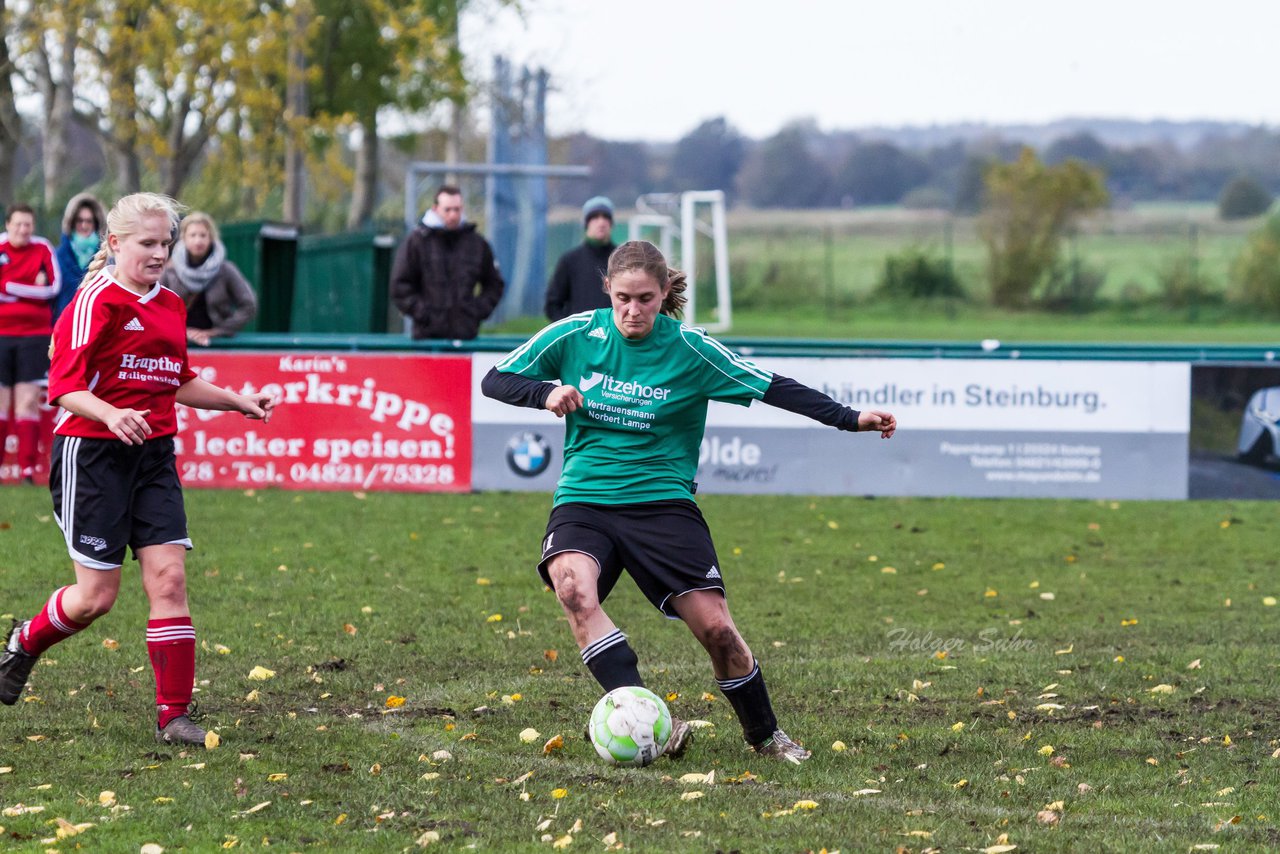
[49,435,191,570]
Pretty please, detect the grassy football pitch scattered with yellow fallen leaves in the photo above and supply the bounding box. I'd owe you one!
[0,488,1280,851]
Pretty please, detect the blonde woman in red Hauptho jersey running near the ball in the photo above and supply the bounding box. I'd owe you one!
[0,193,275,744]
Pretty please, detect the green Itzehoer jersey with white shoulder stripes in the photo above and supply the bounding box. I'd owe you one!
[498,309,773,504]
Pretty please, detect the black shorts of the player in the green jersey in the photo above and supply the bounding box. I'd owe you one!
[538,499,724,620]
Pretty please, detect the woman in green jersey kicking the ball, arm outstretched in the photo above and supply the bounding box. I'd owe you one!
[481,241,897,763]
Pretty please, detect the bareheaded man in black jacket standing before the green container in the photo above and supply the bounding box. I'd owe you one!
[392,186,506,339]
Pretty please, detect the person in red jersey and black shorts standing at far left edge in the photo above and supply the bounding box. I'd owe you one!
[0,205,61,483]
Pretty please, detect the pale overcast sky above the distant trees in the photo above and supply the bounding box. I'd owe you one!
[462,0,1280,141]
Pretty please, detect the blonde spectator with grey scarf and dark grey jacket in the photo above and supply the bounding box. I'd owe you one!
[160,211,257,347]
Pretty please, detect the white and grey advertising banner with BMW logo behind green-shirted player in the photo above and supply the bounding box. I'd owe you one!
[472,353,1190,498]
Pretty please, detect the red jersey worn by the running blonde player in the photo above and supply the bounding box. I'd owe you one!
[49,268,196,439]
